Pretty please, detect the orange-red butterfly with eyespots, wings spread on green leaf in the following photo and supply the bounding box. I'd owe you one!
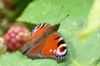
[21,23,67,62]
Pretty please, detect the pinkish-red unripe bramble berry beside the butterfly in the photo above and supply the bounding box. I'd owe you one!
[4,26,29,51]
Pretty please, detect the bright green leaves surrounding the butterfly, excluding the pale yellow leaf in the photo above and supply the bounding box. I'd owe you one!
[0,0,100,66]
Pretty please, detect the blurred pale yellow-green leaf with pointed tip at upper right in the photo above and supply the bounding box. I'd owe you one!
[80,0,100,39]
